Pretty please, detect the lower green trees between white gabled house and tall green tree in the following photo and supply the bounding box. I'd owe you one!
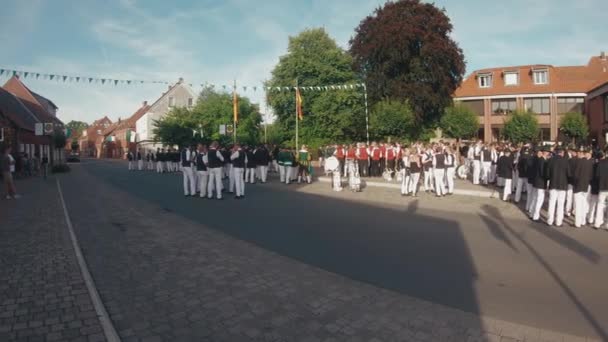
[155,87,262,146]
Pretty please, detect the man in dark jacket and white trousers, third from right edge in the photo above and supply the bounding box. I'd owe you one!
[547,147,568,227]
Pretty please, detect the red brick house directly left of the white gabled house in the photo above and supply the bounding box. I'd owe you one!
[97,101,150,158]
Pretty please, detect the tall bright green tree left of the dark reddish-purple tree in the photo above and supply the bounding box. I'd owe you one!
[267,28,365,145]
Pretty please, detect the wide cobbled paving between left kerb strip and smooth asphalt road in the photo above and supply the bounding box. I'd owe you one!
[57,161,604,342]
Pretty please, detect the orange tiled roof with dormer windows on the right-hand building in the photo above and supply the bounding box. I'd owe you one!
[454,56,608,97]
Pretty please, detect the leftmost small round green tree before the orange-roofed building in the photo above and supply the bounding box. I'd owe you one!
[439,104,479,139]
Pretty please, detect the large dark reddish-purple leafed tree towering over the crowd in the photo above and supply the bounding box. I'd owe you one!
[350,0,465,126]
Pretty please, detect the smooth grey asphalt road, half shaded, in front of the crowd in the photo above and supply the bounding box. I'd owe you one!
[63,160,608,340]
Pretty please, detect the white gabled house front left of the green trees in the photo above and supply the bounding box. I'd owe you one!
[135,78,196,151]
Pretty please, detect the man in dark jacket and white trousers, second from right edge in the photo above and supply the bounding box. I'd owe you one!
[573,149,593,228]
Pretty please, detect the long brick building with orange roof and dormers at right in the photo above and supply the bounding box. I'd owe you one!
[454,53,608,144]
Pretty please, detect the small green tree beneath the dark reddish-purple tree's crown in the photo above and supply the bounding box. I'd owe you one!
[370,100,418,141]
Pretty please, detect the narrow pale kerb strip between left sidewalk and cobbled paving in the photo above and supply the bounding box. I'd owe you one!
[55,178,120,342]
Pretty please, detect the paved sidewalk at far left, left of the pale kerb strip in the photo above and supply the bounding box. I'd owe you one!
[0,177,105,342]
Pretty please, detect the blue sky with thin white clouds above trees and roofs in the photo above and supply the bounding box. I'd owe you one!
[0,0,608,122]
